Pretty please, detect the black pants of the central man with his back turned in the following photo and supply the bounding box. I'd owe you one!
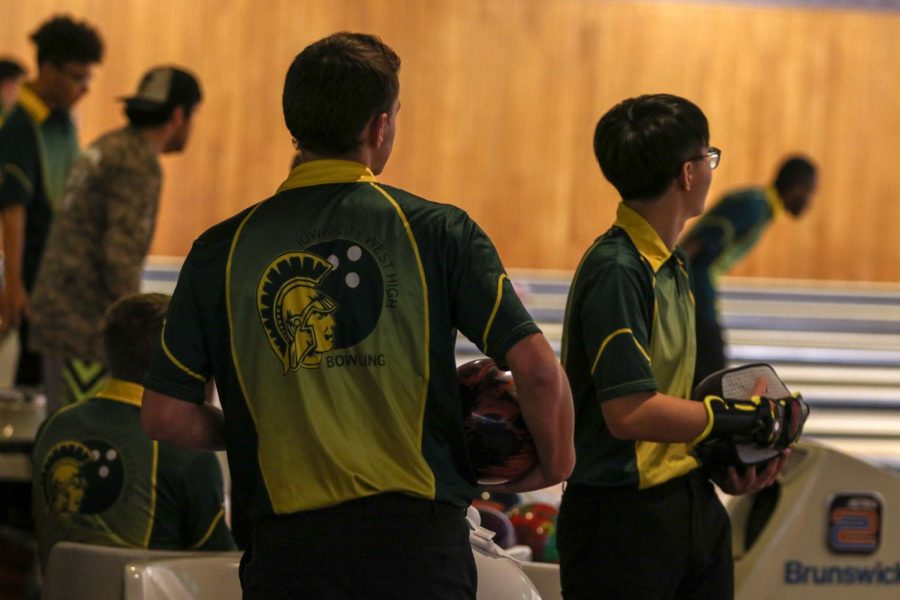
[241,494,477,600]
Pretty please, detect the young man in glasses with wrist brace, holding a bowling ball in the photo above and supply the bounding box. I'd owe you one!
[557,94,800,600]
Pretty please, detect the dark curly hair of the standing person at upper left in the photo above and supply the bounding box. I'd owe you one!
[31,15,103,65]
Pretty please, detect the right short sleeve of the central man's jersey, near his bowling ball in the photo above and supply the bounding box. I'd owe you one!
[450,213,540,365]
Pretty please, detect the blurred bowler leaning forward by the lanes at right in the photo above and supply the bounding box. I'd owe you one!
[679,156,817,385]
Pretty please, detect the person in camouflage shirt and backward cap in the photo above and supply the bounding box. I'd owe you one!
[28,66,202,410]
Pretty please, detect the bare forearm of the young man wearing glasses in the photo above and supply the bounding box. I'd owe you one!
[601,392,709,443]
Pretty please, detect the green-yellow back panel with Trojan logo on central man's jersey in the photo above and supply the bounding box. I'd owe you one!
[228,183,434,513]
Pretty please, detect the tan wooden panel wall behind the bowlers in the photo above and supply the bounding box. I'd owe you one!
[0,0,900,281]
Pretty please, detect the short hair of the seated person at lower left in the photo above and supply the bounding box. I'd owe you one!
[103,294,169,383]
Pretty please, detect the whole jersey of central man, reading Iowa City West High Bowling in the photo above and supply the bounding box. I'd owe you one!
[146,160,539,518]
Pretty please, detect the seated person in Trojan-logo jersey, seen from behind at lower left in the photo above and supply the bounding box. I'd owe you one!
[33,294,234,568]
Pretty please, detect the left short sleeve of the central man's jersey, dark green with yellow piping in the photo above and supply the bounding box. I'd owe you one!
[144,245,211,404]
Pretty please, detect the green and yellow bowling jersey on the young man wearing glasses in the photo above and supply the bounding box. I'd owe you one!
[562,203,697,488]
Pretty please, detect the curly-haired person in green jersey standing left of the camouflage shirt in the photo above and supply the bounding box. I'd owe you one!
[0,16,103,386]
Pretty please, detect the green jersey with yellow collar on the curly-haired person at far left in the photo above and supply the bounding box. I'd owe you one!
[0,84,78,290]
